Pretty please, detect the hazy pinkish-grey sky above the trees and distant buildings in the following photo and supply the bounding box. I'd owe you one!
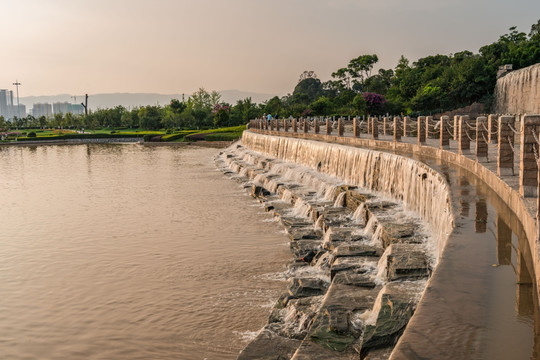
[0,0,540,96]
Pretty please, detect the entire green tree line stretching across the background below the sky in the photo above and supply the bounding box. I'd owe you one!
[0,20,540,129]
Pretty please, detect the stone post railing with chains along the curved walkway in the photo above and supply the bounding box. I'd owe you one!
[249,115,540,204]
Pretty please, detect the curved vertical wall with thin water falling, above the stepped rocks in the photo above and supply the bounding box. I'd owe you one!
[242,131,454,256]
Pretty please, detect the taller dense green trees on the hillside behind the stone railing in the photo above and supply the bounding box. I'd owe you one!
[264,20,540,117]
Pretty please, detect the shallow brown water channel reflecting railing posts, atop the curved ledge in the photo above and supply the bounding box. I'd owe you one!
[404,150,540,360]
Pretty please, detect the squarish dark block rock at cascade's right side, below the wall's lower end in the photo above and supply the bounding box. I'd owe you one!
[387,244,431,281]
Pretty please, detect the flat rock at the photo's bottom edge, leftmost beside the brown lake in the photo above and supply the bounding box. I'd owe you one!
[237,325,301,360]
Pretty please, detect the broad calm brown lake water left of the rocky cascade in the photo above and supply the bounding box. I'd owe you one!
[0,145,290,359]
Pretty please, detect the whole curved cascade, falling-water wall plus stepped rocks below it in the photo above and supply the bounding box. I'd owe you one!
[216,132,453,359]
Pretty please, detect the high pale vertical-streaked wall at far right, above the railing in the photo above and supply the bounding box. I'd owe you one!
[494,64,540,114]
